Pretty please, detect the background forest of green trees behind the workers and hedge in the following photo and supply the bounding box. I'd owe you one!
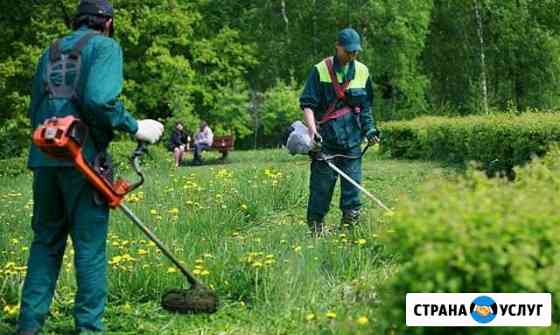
[0,0,560,158]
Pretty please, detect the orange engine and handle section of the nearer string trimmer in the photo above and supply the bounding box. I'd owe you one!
[33,116,144,208]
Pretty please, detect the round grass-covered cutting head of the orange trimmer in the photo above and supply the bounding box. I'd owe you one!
[161,287,219,314]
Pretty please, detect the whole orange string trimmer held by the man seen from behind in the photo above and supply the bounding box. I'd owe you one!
[33,116,218,313]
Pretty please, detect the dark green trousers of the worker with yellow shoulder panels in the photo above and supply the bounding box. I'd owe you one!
[307,146,362,222]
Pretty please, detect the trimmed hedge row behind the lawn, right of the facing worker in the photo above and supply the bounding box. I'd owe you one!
[381,113,560,175]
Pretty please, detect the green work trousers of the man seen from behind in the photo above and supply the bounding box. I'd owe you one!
[18,167,109,332]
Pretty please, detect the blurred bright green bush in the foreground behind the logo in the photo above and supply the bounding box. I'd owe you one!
[381,148,560,334]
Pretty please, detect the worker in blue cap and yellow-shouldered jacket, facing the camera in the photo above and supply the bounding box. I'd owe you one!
[300,28,379,235]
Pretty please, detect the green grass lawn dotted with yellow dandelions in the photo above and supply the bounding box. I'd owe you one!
[0,150,455,334]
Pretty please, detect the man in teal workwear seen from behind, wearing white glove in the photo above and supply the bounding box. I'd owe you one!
[17,0,163,335]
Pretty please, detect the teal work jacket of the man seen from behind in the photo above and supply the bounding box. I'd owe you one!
[28,27,138,169]
